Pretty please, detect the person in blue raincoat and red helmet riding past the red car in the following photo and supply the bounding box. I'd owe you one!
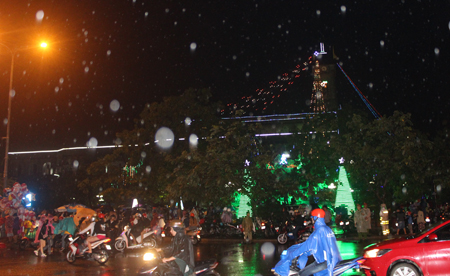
[274,209,342,276]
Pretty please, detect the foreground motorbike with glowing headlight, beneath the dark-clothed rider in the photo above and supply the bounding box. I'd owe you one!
[139,250,220,276]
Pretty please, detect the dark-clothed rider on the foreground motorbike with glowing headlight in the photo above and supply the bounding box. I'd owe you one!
[156,220,194,276]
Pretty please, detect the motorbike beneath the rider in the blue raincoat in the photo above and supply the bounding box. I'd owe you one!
[272,250,364,276]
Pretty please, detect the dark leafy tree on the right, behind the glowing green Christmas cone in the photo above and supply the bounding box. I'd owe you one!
[332,111,432,207]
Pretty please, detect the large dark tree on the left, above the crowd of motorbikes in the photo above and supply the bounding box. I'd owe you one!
[79,89,218,207]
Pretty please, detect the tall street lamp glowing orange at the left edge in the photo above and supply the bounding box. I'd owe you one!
[0,42,47,190]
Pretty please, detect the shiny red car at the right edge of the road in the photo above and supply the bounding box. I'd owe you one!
[361,220,450,276]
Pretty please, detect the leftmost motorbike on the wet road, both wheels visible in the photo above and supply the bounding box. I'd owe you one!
[66,235,111,265]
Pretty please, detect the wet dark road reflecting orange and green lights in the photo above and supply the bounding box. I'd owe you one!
[0,240,368,276]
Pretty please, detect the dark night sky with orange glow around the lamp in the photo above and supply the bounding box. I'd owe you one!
[0,0,450,151]
